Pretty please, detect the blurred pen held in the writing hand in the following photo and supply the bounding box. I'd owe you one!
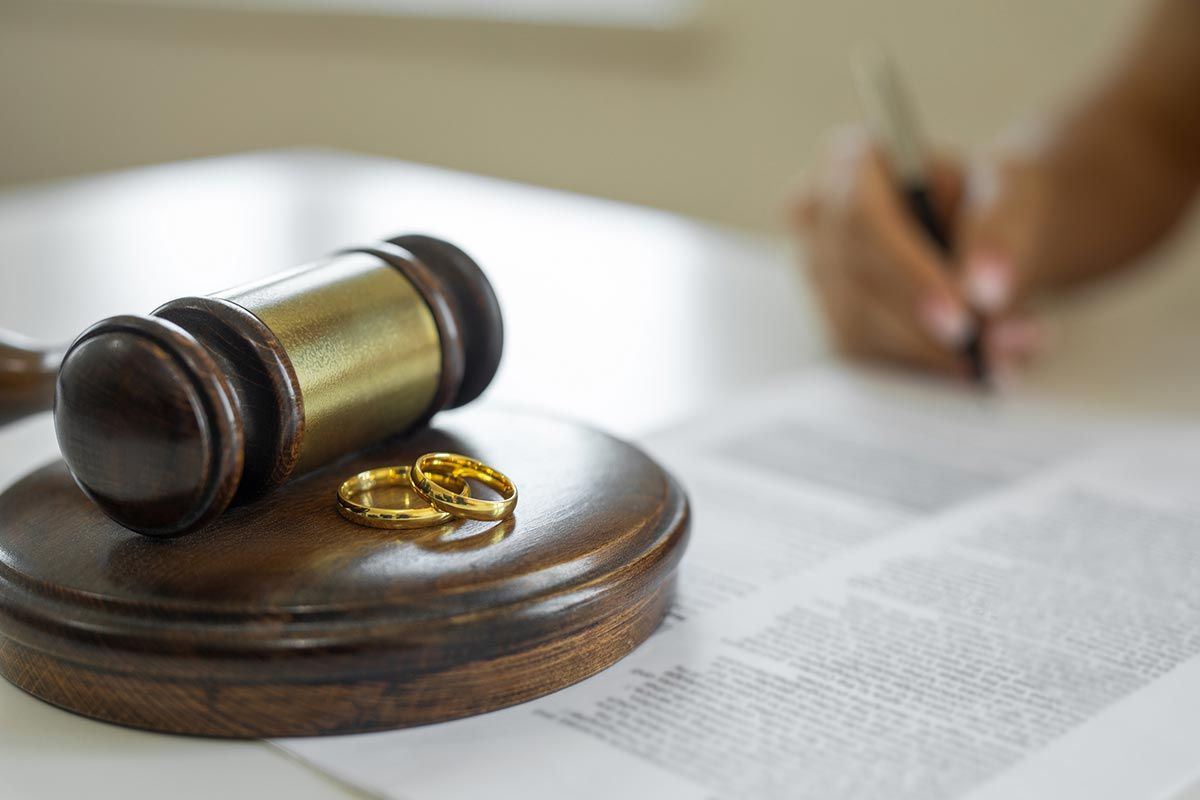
[851,49,988,384]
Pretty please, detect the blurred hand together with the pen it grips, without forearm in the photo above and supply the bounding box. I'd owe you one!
[796,58,1040,381]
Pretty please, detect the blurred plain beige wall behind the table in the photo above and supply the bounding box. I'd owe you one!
[0,0,1139,229]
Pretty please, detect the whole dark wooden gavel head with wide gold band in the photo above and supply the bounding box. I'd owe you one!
[54,235,504,536]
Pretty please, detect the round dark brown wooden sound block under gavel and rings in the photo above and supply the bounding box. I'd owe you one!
[0,411,688,736]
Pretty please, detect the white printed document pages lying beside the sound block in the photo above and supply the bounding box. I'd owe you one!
[276,368,1200,800]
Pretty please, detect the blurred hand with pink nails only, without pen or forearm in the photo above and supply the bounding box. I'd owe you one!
[793,130,1046,378]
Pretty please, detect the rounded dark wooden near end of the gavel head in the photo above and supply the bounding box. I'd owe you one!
[54,315,245,536]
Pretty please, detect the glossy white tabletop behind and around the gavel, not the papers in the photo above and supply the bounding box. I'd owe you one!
[0,151,1200,800]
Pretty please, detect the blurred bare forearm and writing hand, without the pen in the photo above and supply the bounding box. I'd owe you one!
[792,0,1200,384]
